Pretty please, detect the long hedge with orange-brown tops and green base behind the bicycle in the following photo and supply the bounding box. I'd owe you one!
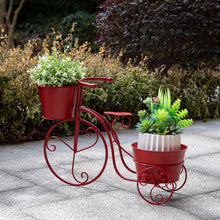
[0,27,220,144]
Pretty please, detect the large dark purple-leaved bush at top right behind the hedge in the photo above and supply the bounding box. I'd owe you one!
[96,0,220,69]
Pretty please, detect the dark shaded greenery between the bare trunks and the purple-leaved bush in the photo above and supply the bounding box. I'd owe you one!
[14,0,102,47]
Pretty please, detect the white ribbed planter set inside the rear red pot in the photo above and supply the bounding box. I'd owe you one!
[137,132,181,151]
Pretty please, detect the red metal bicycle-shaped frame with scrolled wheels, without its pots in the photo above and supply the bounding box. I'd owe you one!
[44,77,187,204]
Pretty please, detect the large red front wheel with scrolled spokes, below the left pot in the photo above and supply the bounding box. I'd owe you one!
[44,119,108,186]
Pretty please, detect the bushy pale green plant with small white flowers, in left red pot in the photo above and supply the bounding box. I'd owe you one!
[29,49,85,87]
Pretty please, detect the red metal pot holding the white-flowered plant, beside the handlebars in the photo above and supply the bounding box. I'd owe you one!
[38,85,79,120]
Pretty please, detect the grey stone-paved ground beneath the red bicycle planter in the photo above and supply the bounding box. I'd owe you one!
[0,119,220,220]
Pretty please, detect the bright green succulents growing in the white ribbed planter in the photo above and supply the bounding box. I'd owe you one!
[136,88,193,135]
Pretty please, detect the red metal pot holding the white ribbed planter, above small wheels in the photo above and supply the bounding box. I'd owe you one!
[132,142,187,184]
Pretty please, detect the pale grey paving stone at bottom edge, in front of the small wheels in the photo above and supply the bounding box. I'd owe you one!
[25,190,199,220]
